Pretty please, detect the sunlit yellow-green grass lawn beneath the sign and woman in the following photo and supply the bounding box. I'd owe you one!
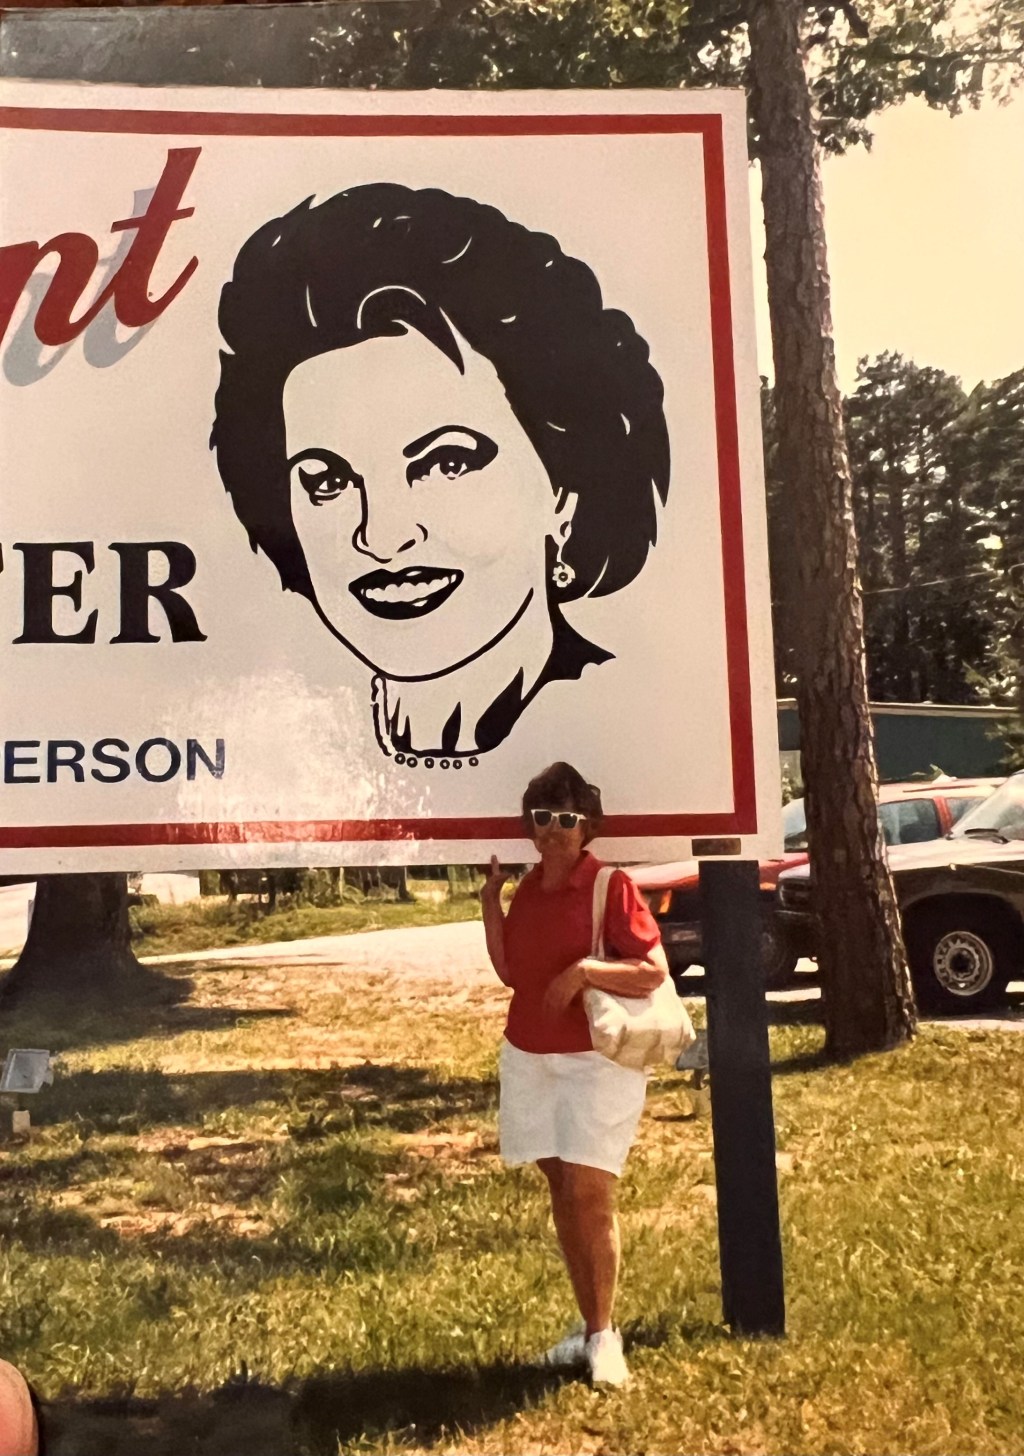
[0,964,1024,1456]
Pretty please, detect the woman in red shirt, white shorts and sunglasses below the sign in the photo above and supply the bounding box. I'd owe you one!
[482,763,669,1385]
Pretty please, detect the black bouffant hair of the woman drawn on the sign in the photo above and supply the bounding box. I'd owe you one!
[211,182,669,601]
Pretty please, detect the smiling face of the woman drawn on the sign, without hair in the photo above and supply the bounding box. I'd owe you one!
[284,329,575,678]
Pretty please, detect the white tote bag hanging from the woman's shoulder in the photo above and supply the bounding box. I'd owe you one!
[583,865,696,1072]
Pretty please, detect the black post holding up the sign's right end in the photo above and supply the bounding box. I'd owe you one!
[701,860,785,1335]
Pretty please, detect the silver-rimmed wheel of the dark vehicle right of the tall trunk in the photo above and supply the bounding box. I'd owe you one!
[907,909,1015,1013]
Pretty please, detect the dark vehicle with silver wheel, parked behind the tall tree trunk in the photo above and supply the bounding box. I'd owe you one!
[776,773,1024,1012]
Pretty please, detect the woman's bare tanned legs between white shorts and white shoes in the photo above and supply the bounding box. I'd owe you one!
[537,1158,621,1337]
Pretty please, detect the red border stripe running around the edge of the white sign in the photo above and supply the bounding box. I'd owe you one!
[0,106,757,849]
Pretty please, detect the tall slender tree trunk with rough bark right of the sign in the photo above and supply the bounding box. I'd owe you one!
[750,0,916,1059]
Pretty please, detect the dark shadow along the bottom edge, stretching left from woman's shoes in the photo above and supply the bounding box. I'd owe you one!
[44,1364,578,1456]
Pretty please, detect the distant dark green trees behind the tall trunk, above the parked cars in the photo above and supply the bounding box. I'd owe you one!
[762,354,1024,713]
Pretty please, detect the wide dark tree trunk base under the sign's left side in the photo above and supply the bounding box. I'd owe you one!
[3,875,154,1009]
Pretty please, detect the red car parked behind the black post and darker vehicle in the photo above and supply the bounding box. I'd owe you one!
[629,775,1002,989]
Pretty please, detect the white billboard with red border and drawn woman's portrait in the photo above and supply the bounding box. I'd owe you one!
[0,82,778,874]
